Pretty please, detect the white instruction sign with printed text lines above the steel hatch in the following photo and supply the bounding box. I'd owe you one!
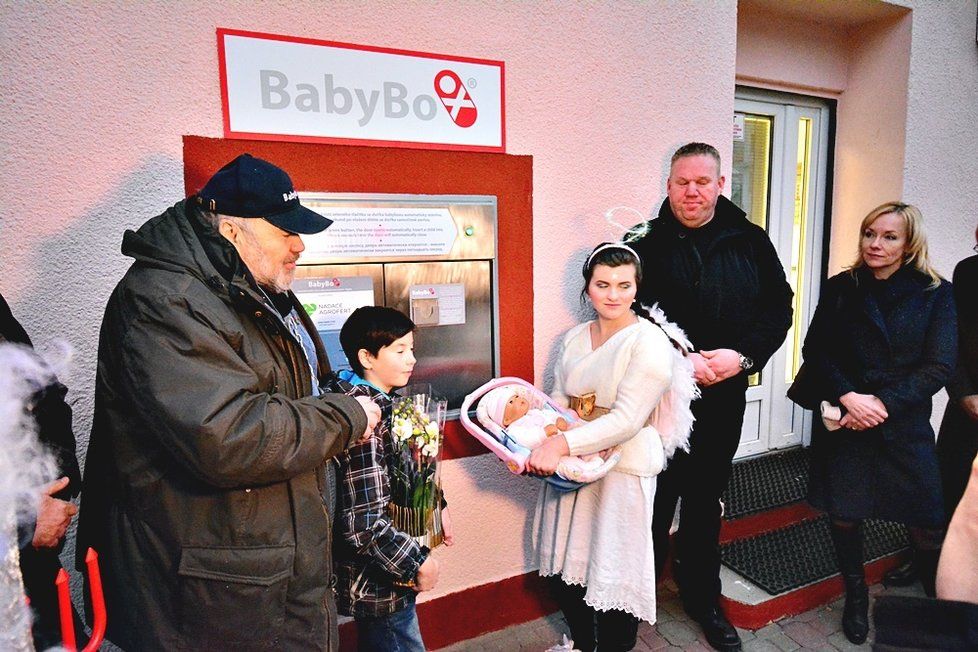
[299,204,458,259]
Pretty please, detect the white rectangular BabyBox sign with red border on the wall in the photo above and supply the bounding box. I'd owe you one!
[217,29,506,152]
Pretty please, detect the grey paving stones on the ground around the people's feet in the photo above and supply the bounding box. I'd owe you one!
[441,580,923,652]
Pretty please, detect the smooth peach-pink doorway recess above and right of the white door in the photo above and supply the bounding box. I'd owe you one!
[737,0,912,275]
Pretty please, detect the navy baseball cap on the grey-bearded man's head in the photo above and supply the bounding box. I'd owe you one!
[197,154,333,233]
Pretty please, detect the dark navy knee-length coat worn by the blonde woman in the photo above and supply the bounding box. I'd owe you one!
[803,267,957,528]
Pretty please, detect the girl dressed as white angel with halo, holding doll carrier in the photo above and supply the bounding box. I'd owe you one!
[527,243,697,652]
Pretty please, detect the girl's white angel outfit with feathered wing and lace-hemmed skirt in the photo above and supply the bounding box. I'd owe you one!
[533,313,696,623]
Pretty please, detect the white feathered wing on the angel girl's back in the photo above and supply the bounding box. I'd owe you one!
[644,304,700,460]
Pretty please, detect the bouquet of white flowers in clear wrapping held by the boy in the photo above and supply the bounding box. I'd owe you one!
[388,387,448,548]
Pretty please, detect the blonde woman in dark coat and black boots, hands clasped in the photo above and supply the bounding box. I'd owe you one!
[803,202,956,644]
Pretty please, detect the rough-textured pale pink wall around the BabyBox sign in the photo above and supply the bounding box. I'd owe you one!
[0,0,736,620]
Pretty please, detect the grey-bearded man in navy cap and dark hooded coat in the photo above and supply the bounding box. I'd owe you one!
[78,154,380,650]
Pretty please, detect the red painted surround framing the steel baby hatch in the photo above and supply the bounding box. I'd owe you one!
[183,136,534,459]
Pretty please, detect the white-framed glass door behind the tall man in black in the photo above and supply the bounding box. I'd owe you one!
[730,89,829,457]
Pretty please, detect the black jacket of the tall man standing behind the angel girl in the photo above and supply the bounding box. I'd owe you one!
[632,195,792,371]
